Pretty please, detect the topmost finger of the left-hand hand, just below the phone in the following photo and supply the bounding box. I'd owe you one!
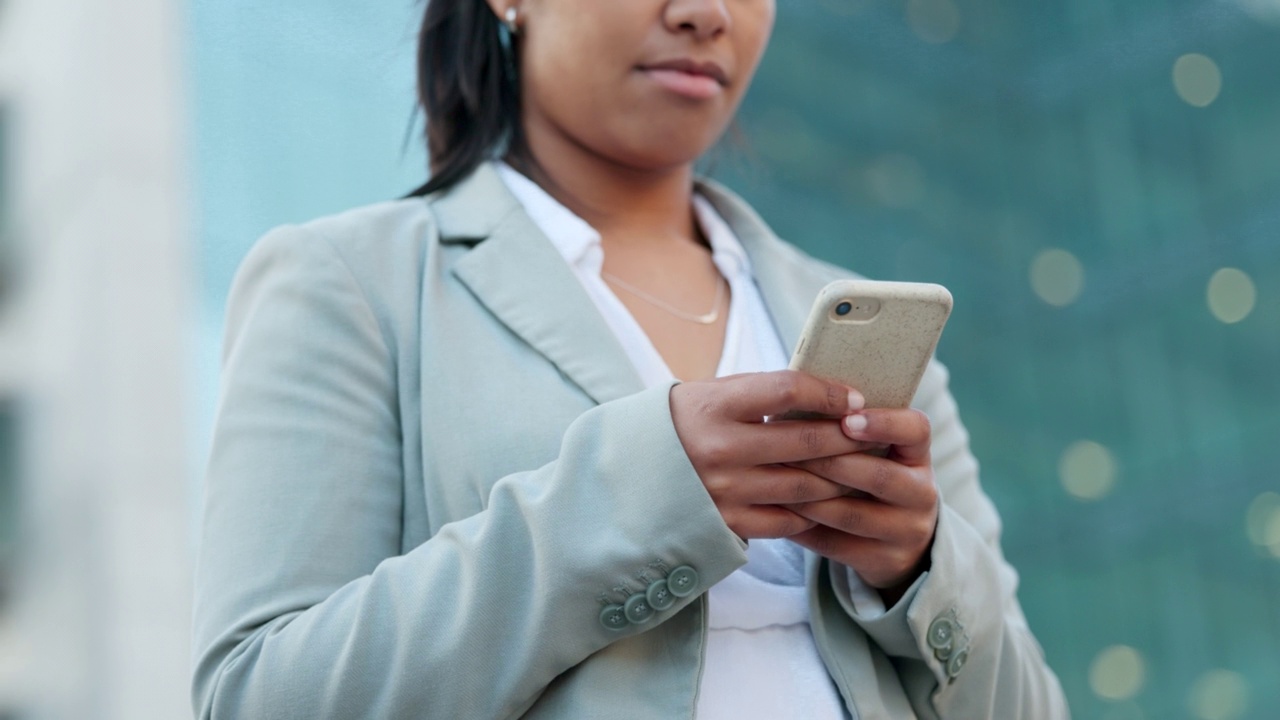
[726,370,864,421]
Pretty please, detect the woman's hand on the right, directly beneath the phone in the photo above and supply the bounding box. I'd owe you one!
[787,410,938,606]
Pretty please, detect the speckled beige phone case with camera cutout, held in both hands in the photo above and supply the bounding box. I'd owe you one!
[791,275,951,407]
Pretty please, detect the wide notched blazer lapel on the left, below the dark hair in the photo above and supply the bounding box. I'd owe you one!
[431,164,644,402]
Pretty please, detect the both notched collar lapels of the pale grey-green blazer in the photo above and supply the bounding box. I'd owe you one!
[428,164,838,402]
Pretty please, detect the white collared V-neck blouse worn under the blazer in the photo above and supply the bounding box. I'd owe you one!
[498,163,884,720]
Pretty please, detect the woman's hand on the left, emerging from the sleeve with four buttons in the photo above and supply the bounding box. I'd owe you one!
[671,370,872,538]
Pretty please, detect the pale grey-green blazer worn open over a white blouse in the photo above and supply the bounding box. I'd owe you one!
[193,165,1068,720]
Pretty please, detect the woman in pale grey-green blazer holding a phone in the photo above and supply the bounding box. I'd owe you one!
[195,0,1066,720]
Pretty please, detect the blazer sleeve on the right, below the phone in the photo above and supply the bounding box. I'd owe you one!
[832,363,1070,720]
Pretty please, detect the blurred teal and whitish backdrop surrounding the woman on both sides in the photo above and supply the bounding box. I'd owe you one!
[0,0,1280,720]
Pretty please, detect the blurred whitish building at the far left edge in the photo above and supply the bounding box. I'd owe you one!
[0,0,192,720]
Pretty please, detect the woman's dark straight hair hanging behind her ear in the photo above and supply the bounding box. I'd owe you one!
[410,0,526,197]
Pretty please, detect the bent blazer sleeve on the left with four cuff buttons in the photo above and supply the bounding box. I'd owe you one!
[193,228,746,720]
